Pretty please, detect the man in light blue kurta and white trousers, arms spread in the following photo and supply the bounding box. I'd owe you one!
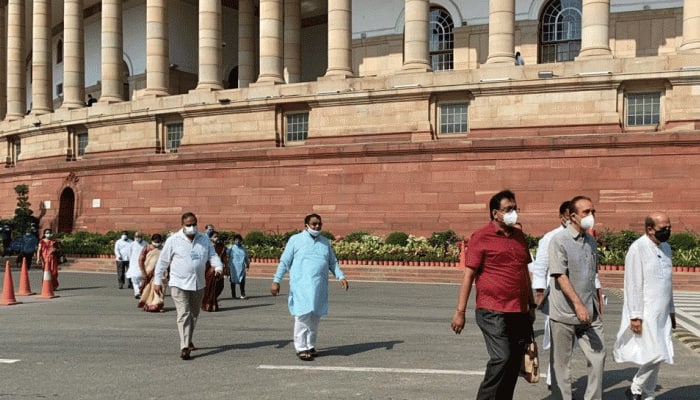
[270,214,349,361]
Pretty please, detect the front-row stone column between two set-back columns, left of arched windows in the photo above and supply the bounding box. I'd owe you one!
[258,0,284,84]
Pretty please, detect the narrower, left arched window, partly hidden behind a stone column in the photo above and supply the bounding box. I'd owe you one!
[430,7,454,71]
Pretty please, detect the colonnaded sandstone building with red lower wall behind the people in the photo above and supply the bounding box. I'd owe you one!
[0,0,700,235]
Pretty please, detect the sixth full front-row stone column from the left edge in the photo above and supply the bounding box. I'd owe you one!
[197,0,223,90]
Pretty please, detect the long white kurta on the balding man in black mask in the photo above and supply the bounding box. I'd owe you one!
[613,235,675,365]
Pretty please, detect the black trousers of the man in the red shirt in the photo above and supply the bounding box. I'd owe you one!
[476,309,532,400]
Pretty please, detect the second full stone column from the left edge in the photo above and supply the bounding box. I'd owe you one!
[31,0,53,115]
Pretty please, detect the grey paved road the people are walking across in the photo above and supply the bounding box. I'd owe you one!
[0,271,700,400]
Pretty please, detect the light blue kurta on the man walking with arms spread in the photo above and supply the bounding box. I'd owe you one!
[273,231,345,317]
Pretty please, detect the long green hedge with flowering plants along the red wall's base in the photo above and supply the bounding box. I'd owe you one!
[24,230,700,267]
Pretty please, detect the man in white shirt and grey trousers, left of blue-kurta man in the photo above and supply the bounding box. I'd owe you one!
[153,212,224,360]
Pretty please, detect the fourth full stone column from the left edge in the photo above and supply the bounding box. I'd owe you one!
[100,0,124,102]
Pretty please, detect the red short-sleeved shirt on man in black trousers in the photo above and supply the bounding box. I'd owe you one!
[467,222,532,312]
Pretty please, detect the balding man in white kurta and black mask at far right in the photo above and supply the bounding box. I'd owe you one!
[613,212,676,400]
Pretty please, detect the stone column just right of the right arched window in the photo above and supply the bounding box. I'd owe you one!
[577,0,612,58]
